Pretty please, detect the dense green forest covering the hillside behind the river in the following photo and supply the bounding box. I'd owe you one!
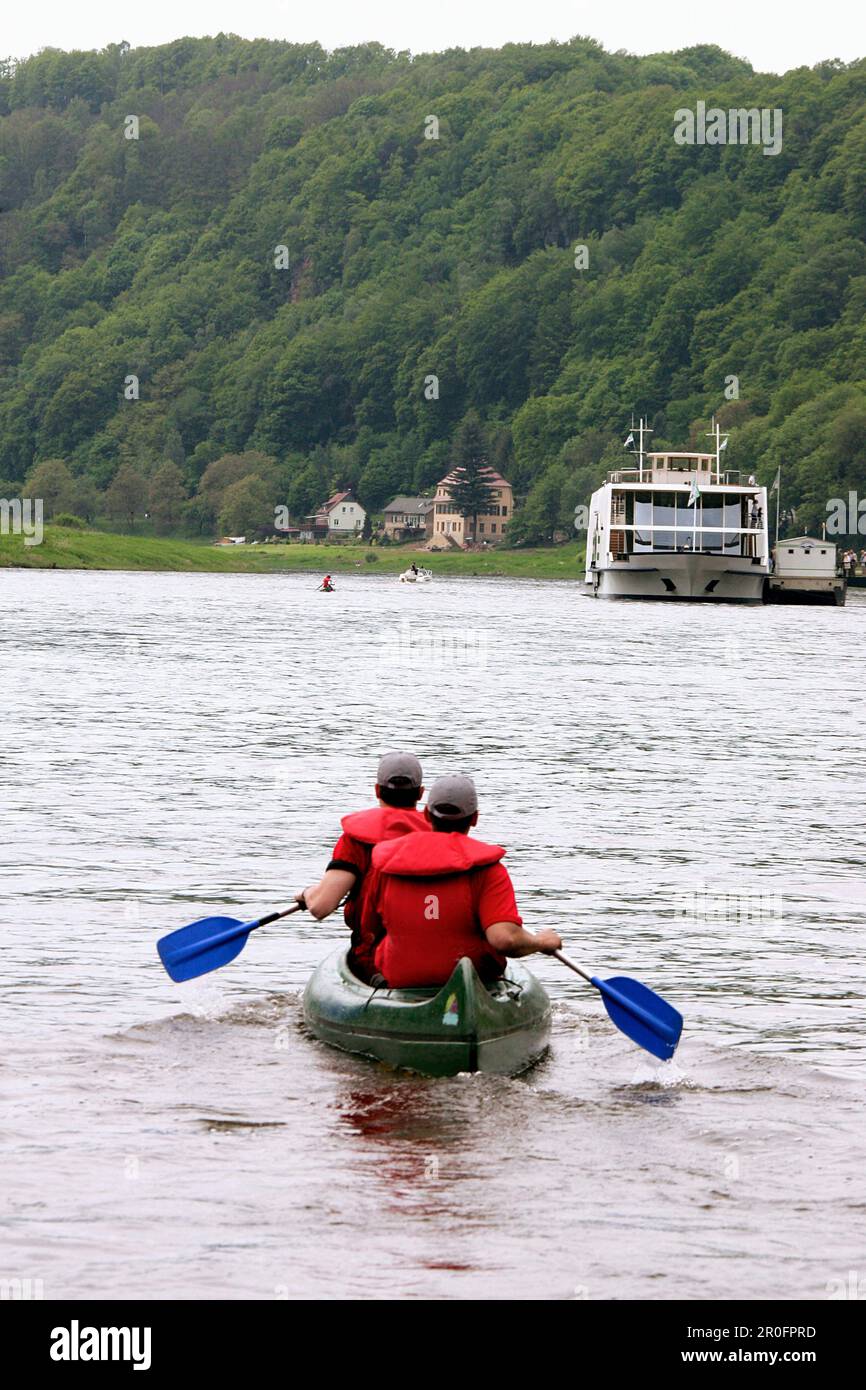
[0,35,866,542]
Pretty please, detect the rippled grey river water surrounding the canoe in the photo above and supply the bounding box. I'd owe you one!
[0,571,866,1300]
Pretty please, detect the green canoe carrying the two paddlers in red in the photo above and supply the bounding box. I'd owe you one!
[303,947,550,1076]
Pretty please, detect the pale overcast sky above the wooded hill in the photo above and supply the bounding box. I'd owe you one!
[0,0,866,72]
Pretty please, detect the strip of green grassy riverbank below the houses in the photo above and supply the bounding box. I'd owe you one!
[0,525,584,580]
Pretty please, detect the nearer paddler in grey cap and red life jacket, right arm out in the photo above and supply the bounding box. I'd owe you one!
[363,777,562,988]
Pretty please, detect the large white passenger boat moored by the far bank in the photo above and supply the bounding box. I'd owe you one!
[587,420,770,603]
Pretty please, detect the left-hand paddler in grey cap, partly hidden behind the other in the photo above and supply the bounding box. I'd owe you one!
[296,752,428,980]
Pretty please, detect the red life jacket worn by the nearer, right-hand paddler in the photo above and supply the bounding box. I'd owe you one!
[370,830,506,988]
